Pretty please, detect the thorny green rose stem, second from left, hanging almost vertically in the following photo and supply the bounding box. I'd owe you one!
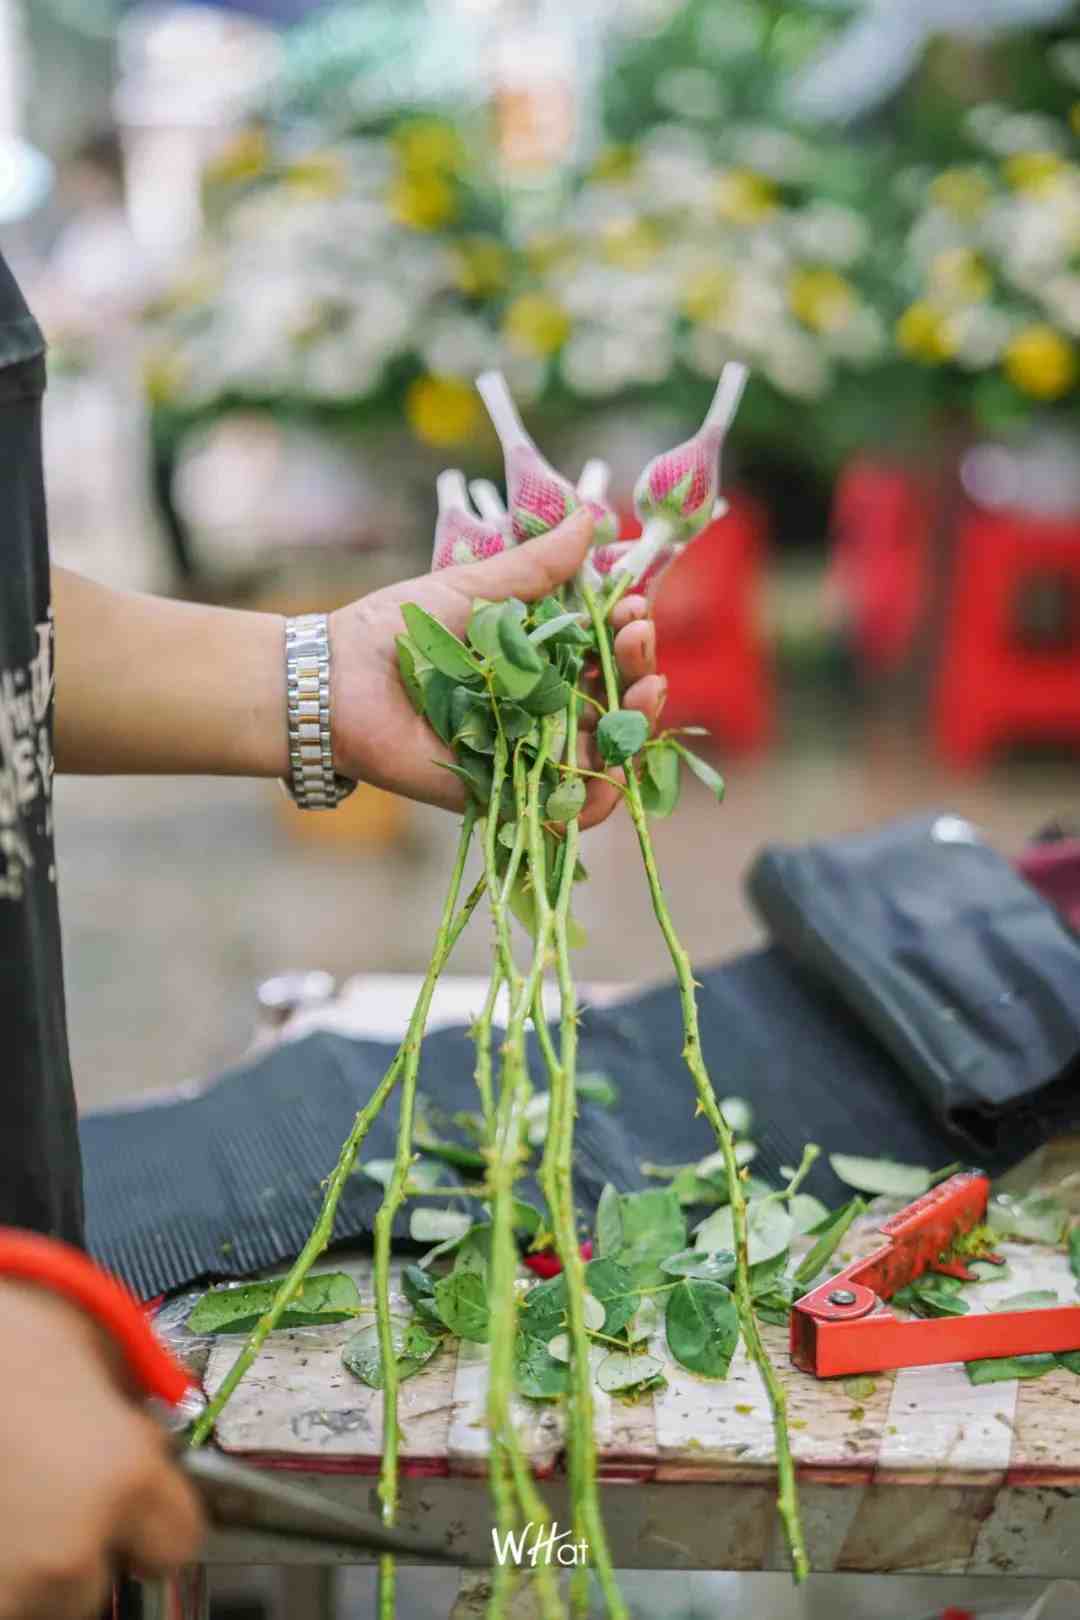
[376,805,476,1555]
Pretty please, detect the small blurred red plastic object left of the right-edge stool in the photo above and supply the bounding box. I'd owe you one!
[829,455,931,674]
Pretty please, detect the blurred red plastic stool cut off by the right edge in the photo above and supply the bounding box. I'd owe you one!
[933,512,1080,765]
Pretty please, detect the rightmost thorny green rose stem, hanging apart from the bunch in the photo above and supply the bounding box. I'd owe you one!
[585,590,810,1581]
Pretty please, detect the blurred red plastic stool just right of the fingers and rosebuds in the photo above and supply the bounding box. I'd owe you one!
[641,494,776,753]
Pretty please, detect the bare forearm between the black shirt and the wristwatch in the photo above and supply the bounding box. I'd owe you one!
[52,569,288,776]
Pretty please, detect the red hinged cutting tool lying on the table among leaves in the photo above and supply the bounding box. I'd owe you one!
[792,1170,1080,1379]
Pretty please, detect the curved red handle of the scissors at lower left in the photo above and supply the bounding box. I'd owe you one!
[0,1226,196,1406]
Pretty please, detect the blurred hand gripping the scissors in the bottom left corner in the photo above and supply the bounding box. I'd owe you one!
[0,1283,202,1620]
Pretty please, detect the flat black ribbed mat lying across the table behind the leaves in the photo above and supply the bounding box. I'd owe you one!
[83,949,1080,1298]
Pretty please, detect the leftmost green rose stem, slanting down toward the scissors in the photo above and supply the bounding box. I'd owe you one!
[191,870,486,1445]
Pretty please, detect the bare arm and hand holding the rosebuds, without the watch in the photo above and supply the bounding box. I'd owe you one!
[53,517,662,823]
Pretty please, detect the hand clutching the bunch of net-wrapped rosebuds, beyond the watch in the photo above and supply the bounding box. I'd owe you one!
[330,512,665,828]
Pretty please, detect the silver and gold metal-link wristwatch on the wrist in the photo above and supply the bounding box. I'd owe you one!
[282,612,356,810]
